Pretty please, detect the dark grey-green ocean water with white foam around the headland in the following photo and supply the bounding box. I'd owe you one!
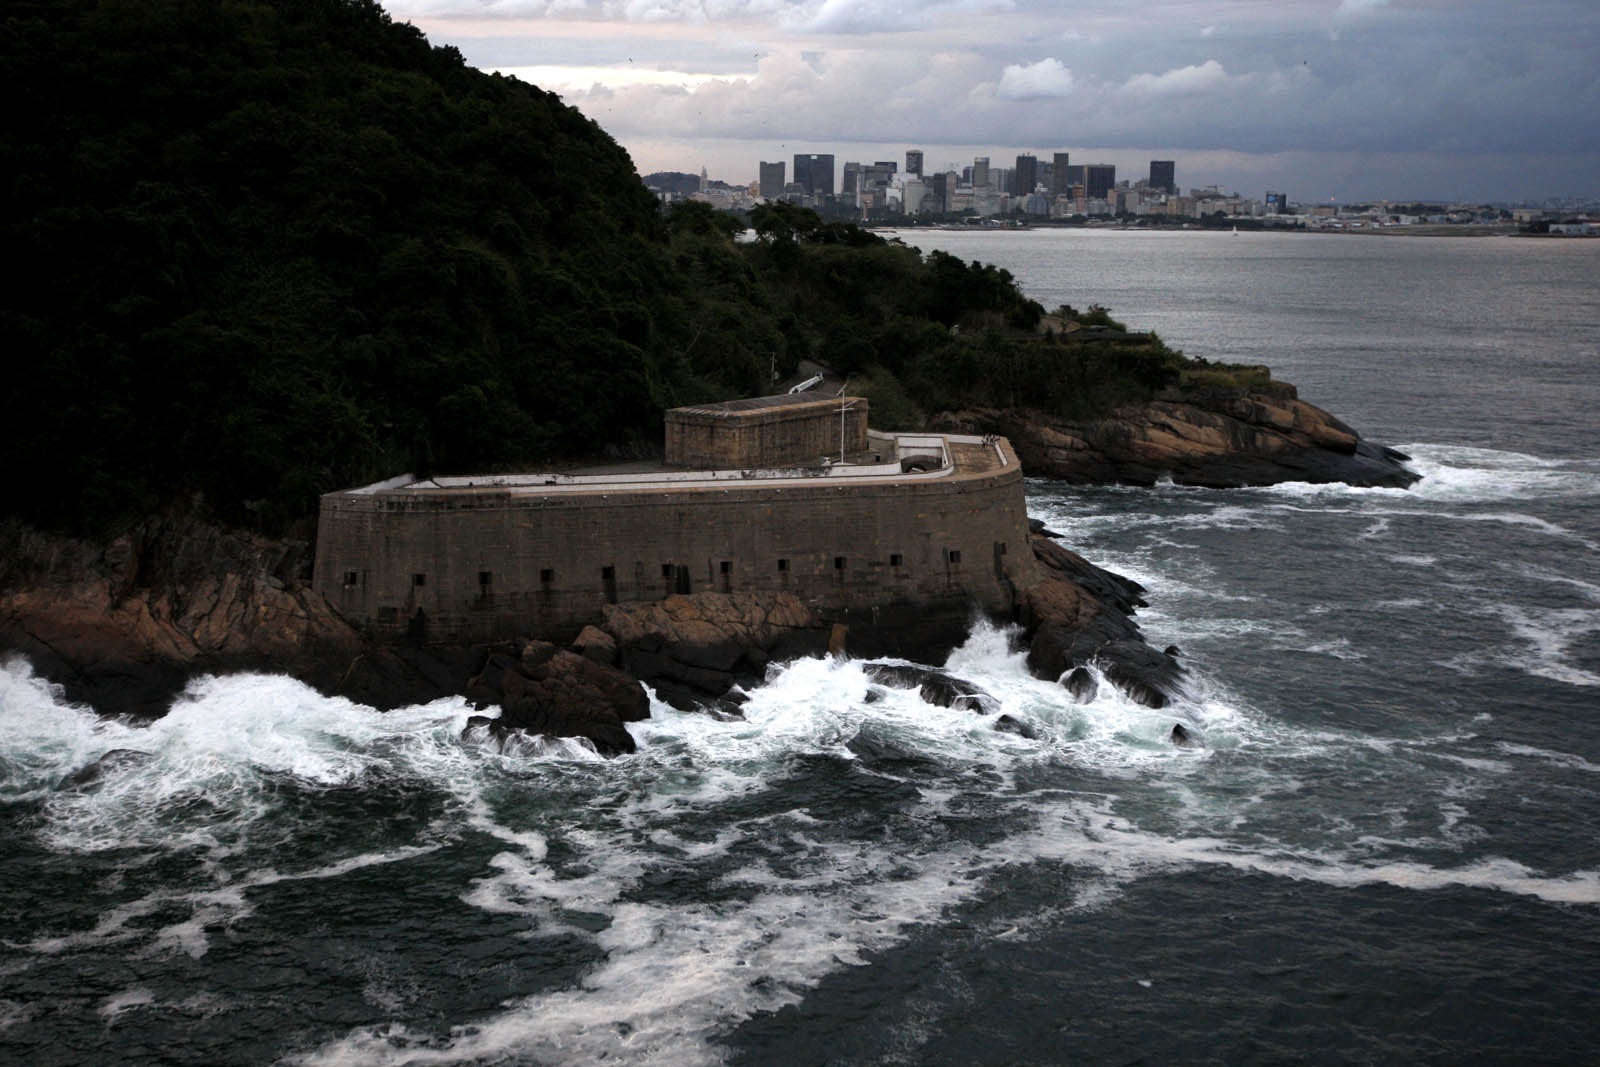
[0,232,1600,1065]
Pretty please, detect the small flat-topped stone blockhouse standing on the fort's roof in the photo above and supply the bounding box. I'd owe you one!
[666,397,867,470]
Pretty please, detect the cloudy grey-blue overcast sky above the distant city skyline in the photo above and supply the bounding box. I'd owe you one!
[386,0,1600,203]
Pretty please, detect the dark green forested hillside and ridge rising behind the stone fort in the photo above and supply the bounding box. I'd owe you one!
[0,0,1203,531]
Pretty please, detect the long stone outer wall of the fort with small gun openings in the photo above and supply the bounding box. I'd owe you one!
[314,451,1029,640]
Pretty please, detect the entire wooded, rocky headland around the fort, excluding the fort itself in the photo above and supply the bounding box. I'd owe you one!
[0,0,1411,752]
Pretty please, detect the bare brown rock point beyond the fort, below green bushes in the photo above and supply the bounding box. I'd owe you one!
[944,382,1418,488]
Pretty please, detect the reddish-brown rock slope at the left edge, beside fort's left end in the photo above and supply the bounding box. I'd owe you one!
[0,514,482,718]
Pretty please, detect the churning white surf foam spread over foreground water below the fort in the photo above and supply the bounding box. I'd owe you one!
[5,604,1600,1064]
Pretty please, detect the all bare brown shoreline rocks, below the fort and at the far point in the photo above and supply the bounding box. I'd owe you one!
[0,395,1416,755]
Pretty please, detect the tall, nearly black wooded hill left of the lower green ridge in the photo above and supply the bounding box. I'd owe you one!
[0,0,691,531]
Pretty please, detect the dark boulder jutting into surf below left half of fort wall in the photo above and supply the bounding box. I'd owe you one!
[466,641,650,755]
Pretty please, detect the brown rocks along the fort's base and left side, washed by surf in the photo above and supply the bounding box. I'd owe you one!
[0,512,1181,755]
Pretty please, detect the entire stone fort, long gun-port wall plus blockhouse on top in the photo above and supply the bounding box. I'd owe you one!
[314,394,1030,640]
